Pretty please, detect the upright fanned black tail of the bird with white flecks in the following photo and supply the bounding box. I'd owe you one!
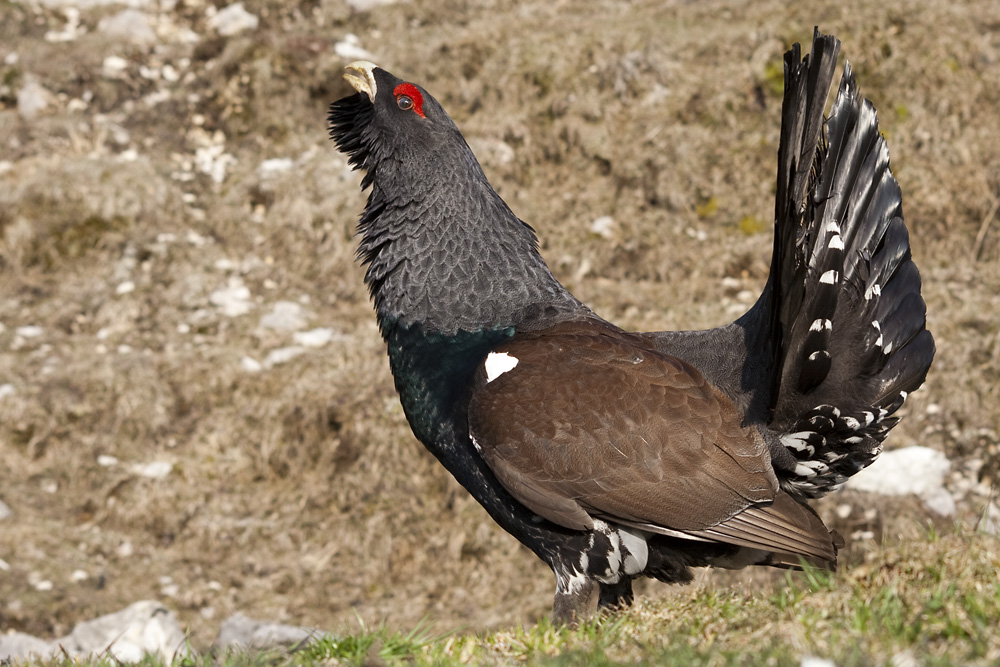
[768,31,934,497]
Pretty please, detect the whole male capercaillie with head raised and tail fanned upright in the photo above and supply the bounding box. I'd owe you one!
[329,31,934,620]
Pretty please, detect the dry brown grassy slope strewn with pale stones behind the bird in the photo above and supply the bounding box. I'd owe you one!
[0,0,1000,645]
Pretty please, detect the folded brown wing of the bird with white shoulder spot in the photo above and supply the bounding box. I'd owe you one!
[469,323,835,558]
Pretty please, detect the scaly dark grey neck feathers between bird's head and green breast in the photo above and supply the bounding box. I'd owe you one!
[358,131,586,336]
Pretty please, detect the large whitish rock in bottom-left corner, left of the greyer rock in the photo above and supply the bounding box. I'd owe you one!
[56,600,185,663]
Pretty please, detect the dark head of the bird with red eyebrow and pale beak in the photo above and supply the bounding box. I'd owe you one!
[328,60,468,187]
